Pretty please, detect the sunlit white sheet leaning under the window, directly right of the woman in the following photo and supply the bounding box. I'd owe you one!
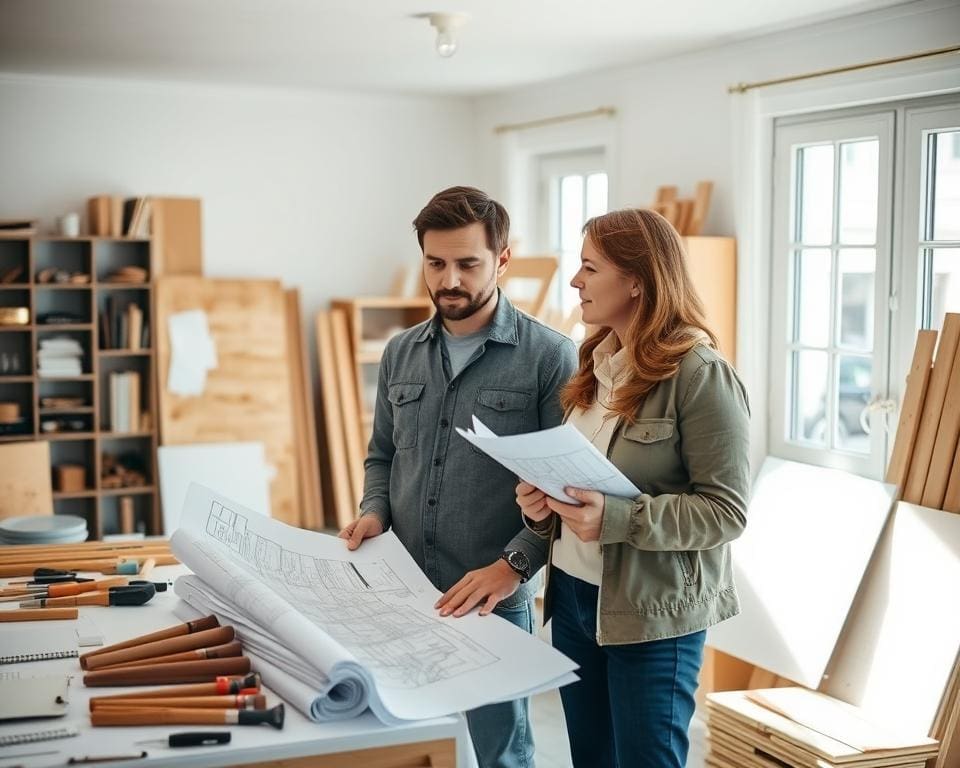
[707,458,895,688]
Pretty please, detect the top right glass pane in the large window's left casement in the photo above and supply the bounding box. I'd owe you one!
[839,139,880,245]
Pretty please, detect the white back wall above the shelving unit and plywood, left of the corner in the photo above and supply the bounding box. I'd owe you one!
[0,75,476,318]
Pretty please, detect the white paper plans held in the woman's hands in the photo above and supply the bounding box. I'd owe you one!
[457,416,640,504]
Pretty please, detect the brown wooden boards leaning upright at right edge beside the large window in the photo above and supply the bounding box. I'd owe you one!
[887,313,960,512]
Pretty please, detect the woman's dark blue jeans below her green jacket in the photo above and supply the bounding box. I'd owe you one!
[550,568,706,768]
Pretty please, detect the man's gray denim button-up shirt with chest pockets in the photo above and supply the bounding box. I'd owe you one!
[360,292,577,607]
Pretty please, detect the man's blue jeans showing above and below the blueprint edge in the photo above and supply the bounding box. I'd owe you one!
[467,600,534,768]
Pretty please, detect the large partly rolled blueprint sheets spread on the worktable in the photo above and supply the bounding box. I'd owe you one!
[171,485,577,723]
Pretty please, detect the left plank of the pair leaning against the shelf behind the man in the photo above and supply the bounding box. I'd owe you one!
[316,310,359,529]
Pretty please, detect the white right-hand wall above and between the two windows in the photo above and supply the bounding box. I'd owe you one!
[477,0,960,235]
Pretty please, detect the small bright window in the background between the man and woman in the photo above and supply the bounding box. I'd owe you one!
[539,150,609,316]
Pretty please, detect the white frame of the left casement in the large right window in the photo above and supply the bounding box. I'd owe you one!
[768,110,895,477]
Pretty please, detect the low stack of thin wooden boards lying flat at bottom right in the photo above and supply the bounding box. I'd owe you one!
[706,688,937,768]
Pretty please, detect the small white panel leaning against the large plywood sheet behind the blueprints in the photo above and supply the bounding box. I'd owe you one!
[157,442,271,536]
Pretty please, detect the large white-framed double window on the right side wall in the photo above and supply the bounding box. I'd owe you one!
[769,98,960,477]
